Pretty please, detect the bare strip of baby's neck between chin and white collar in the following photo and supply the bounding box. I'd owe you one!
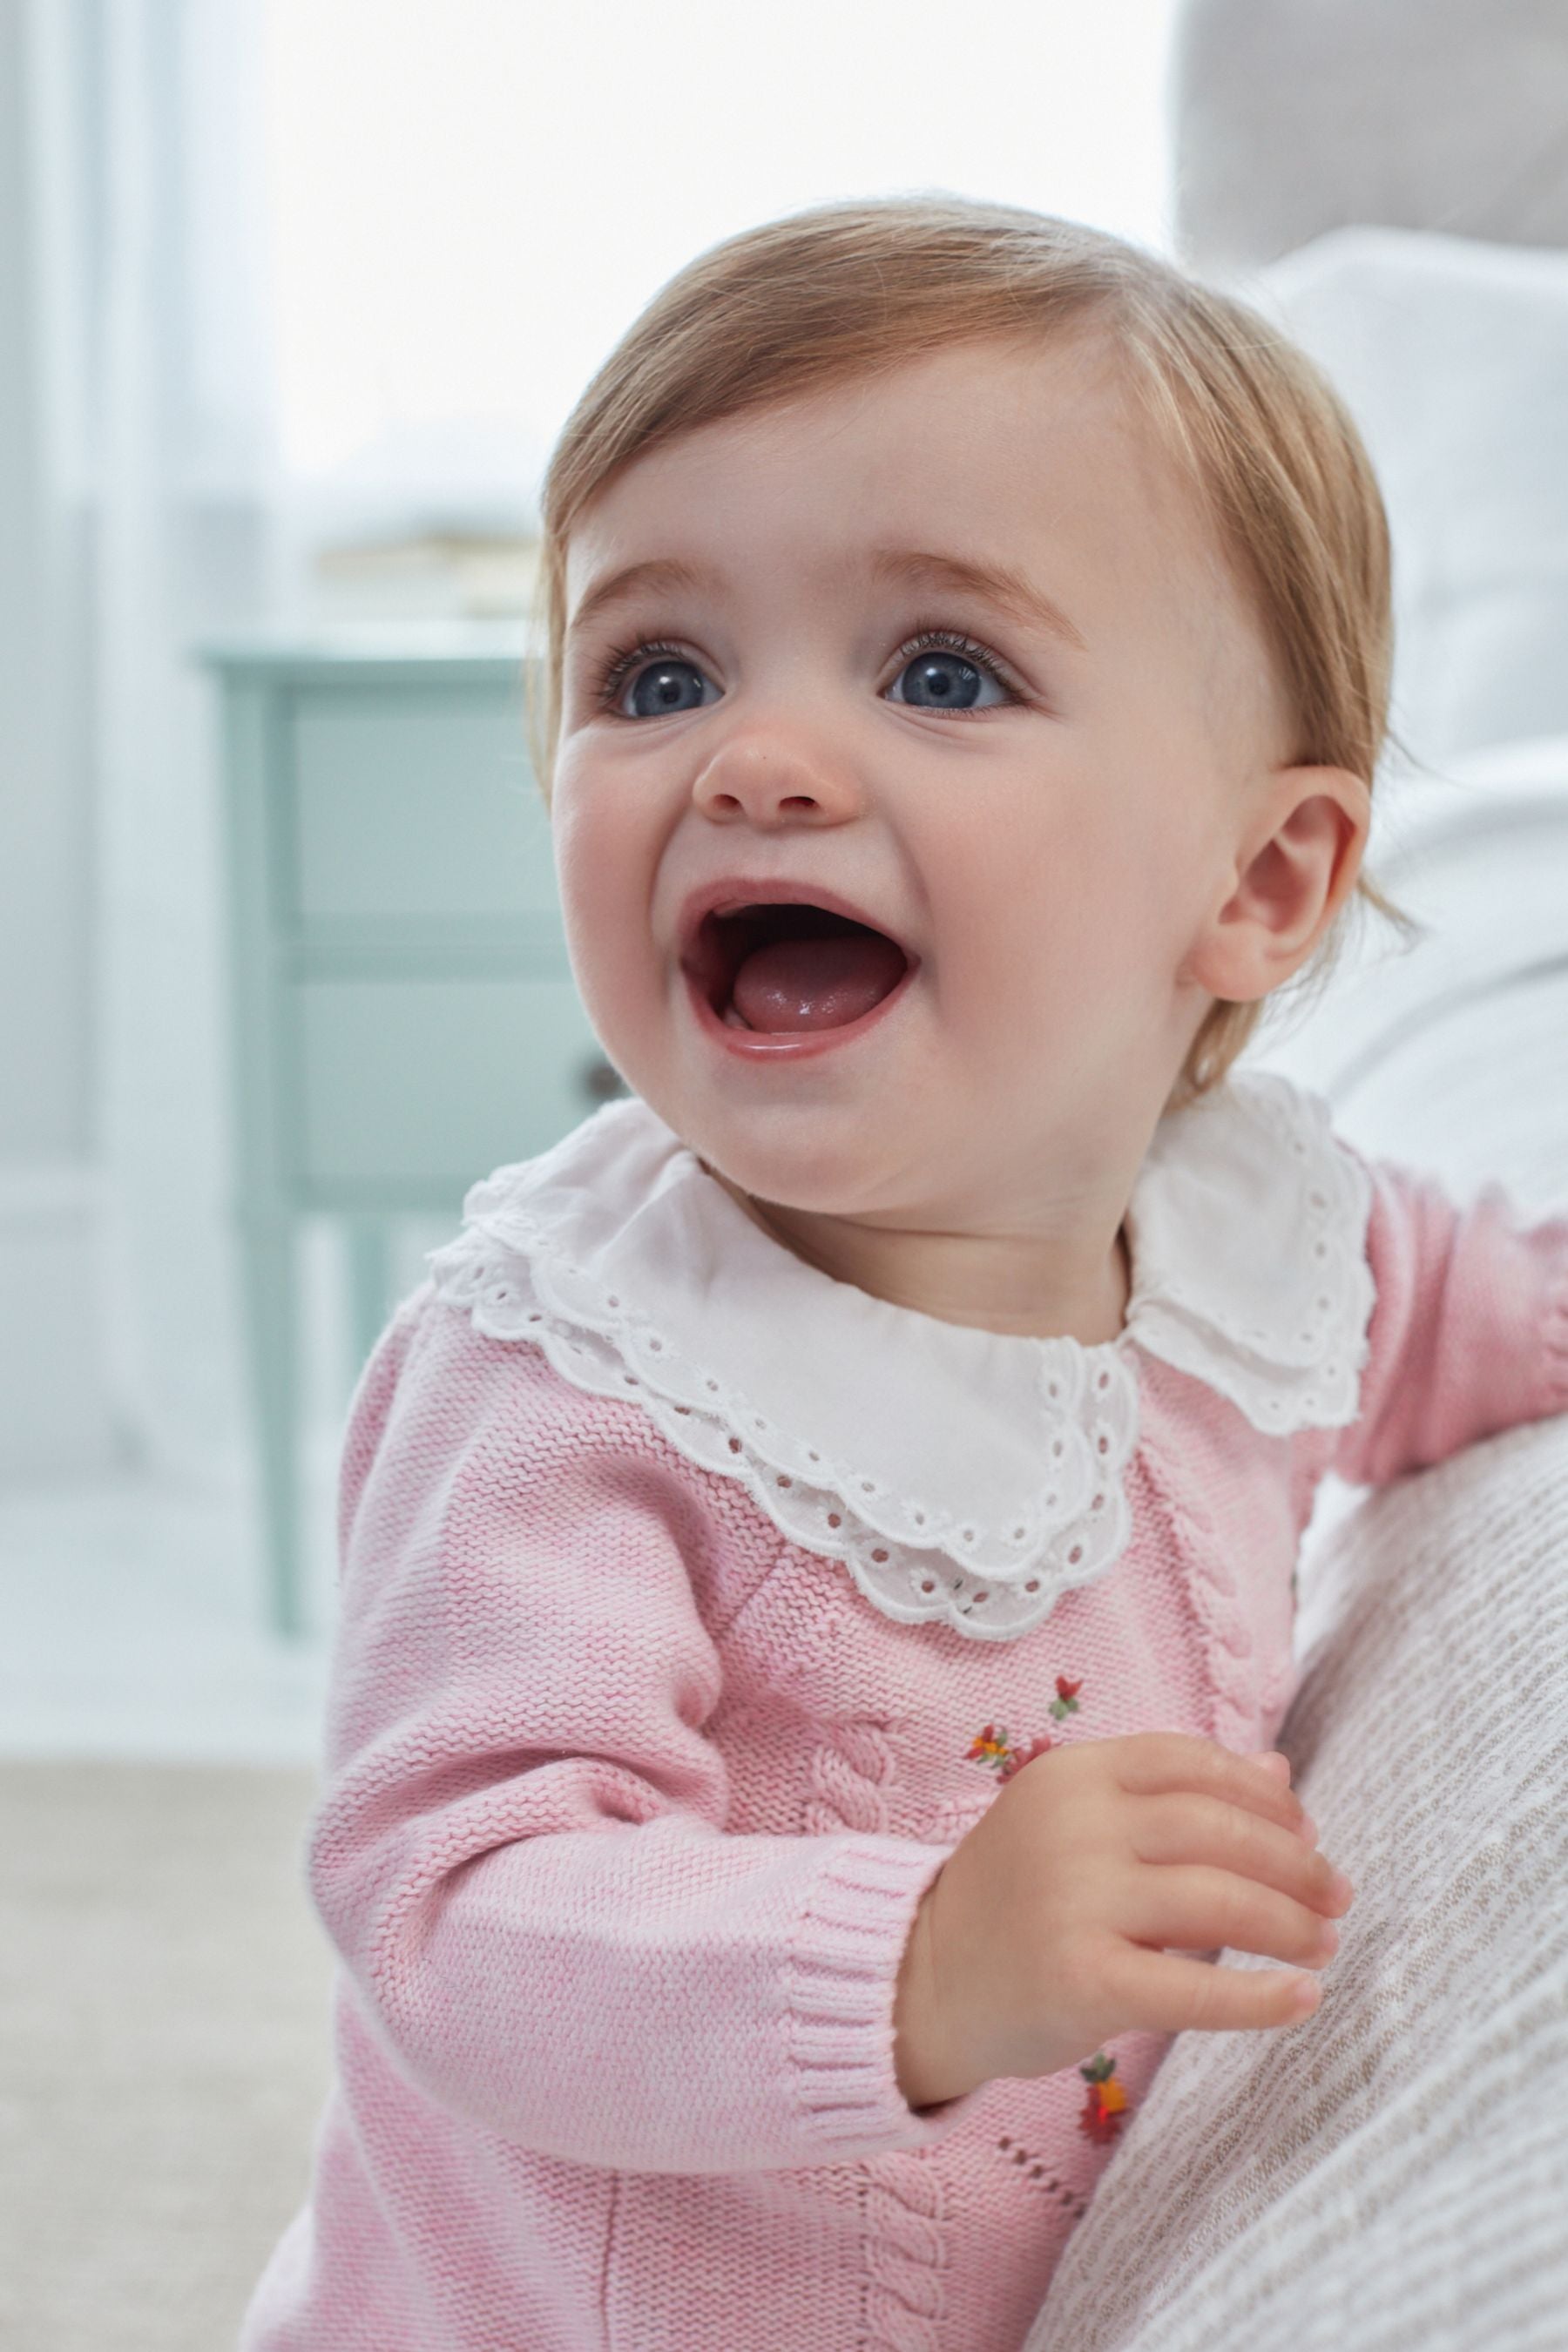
[710,1169,1131,1348]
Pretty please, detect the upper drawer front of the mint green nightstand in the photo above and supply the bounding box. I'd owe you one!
[275,675,559,927]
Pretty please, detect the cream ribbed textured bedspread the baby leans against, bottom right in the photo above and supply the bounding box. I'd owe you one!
[1023,1418,1568,2352]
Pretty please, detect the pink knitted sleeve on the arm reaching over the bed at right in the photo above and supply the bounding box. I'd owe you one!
[1330,1165,1568,1486]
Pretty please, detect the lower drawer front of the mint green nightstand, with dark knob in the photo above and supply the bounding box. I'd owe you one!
[294,978,616,1212]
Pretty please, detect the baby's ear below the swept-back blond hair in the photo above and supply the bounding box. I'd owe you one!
[1187,767,1373,1004]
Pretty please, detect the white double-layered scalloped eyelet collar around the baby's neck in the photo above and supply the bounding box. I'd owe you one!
[428,1072,1373,1642]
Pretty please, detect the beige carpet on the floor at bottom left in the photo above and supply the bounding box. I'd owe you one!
[0,1761,332,2352]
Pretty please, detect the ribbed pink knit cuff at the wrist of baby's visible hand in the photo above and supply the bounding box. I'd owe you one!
[785,1837,980,2164]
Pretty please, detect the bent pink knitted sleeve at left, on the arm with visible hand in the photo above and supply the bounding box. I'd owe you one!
[308,1294,980,2173]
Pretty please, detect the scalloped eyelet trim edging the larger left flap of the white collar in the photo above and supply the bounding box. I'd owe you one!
[430,1226,1138,1642]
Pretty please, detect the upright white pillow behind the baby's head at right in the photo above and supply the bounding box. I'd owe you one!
[1218,228,1568,765]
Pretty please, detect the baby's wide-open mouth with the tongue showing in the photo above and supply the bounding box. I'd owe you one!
[686,901,909,1035]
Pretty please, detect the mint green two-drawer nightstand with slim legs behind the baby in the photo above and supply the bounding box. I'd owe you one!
[202,639,623,1635]
